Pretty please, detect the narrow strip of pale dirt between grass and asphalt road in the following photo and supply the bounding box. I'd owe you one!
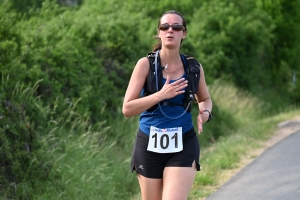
[218,116,300,190]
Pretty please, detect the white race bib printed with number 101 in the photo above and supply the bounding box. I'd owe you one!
[147,126,183,153]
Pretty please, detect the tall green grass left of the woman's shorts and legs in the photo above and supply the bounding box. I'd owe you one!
[29,111,138,200]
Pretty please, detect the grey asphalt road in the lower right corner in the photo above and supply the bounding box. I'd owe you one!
[206,131,300,200]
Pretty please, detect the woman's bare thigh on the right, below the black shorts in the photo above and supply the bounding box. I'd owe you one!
[162,161,197,200]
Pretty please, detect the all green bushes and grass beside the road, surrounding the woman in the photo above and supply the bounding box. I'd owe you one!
[0,0,300,200]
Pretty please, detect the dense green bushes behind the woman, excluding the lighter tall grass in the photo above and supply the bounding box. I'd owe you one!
[0,0,300,199]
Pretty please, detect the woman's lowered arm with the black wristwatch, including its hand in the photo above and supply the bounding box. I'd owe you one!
[196,65,213,134]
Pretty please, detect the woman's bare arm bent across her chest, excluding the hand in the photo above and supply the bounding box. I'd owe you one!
[122,57,163,117]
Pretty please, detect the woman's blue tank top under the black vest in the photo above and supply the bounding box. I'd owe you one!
[140,74,193,135]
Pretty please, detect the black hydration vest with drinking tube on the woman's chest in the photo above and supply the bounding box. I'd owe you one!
[142,52,201,112]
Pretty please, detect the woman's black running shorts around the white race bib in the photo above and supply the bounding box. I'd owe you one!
[131,128,200,179]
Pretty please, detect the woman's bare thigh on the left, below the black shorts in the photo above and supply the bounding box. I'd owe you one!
[137,174,163,200]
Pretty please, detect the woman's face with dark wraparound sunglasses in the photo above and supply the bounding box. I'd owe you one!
[158,14,186,49]
